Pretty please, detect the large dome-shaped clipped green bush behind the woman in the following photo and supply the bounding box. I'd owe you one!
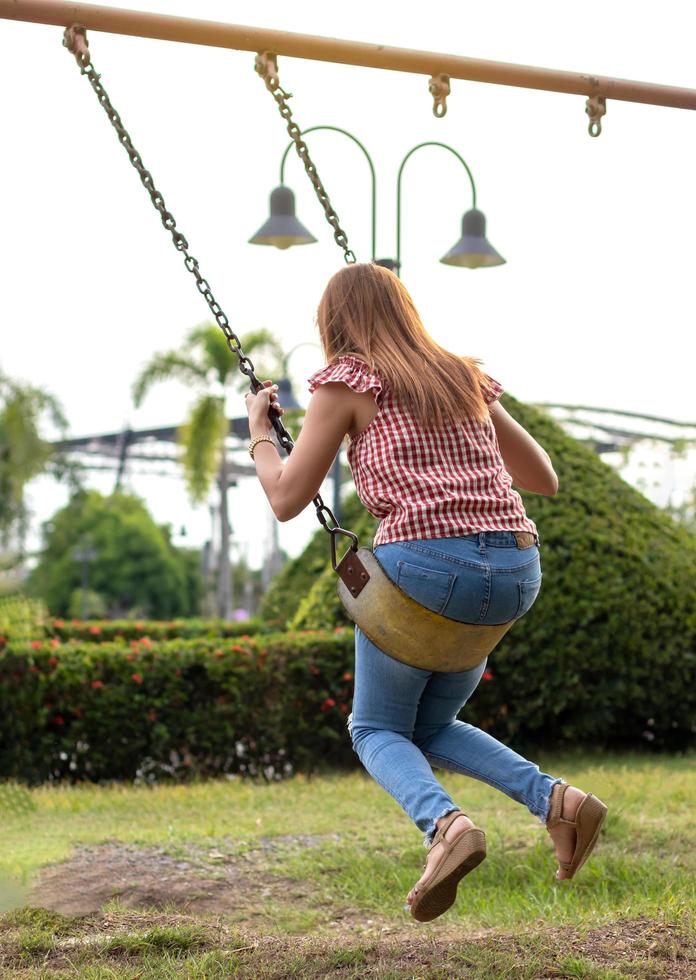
[258,396,696,747]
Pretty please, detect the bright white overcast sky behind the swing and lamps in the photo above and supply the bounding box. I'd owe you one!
[0,0,696,561]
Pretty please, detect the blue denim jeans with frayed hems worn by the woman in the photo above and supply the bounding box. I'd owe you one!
[348,531,562,847]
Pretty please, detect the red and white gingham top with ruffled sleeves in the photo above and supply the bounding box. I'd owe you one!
[309,354,536,547]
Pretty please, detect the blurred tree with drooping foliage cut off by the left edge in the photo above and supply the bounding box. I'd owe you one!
[0,372,72,565]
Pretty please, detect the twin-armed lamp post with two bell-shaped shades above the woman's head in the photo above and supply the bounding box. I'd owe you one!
[249,126,505,275]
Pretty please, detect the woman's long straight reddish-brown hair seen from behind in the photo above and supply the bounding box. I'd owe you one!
[317,262,489,428]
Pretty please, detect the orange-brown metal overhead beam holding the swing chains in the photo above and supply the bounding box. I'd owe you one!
[0,0,696,109]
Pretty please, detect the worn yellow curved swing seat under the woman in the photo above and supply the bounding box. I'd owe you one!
[336,548,515,673]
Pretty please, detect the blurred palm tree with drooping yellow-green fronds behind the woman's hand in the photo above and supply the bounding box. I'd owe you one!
[133,323,283,619]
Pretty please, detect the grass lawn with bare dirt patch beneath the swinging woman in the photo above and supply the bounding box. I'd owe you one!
[0,753,696,980]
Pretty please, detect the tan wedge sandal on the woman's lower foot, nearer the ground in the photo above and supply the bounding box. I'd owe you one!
[411,810,486,922]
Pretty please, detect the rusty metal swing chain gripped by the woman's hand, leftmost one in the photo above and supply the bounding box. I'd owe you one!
[63,24,342,533]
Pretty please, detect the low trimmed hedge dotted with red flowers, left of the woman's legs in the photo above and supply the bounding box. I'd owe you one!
[0,629,355,784]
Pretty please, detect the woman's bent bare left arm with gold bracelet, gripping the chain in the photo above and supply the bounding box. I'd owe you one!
[246,381,364,521]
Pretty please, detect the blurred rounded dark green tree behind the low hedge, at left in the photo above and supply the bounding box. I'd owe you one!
[27,490,202,618]
